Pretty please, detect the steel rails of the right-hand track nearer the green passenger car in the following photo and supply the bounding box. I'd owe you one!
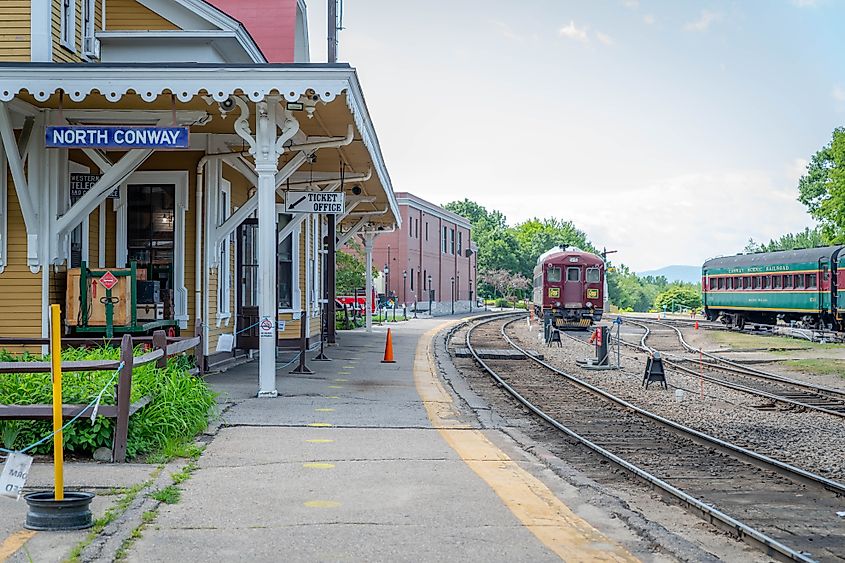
[622,320,845,418]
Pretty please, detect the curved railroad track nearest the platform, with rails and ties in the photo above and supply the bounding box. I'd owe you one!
[465,312,845,561]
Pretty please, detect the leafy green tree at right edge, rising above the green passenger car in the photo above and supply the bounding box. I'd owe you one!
[798,127,845,243]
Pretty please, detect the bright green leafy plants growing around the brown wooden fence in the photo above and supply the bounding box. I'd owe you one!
[0,347,215,457]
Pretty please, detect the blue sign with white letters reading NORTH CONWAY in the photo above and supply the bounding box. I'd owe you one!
[47,125,190,150]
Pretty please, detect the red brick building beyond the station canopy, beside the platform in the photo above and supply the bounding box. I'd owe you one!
[373,192,477,314]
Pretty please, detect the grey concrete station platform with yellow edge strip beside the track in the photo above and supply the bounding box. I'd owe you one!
[129,319,630,562]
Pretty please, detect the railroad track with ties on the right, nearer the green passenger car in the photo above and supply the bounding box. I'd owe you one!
[622,320,845,418]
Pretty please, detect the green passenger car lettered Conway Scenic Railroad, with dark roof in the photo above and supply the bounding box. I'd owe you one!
[701,246,845,329]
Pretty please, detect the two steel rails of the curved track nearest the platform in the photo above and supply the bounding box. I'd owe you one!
[466,319,824,562]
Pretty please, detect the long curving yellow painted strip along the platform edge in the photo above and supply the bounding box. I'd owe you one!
[414,321,637,562]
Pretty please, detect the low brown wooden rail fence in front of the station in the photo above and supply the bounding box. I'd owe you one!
[0,330,203,463]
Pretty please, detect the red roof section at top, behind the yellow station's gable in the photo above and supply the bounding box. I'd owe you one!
[206,0,297,63]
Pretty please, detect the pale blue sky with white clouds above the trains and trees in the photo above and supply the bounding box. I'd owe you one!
[308,0,845,271]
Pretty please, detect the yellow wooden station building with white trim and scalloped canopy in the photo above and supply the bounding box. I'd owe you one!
[0,0,400,396]
